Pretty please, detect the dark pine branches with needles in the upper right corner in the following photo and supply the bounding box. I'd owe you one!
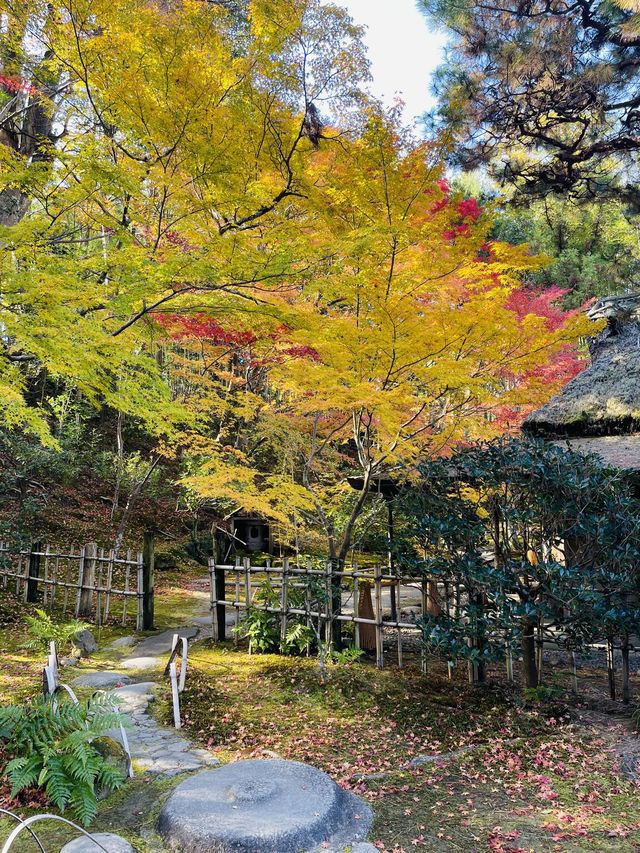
[422,0,640,206]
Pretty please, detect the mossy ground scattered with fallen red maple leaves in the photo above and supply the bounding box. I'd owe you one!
[0,573,640,853]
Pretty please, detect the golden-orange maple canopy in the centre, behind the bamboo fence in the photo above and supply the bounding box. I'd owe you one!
[179,110,584,561]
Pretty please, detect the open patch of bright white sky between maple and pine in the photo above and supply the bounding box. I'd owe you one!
[336,0,445,122]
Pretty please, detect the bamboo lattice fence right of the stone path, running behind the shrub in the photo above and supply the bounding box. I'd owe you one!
[209,558,640,704]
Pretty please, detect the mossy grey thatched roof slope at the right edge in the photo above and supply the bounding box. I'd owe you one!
[523,321,640,438]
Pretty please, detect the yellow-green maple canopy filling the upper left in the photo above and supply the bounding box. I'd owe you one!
[0,0,367,440]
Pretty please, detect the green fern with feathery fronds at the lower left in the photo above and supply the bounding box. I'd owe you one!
[0,694,124,826]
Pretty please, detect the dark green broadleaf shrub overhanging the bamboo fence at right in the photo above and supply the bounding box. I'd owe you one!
[398,439,640,687]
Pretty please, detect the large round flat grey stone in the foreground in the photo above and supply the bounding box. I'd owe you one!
[158,759,372,853]
